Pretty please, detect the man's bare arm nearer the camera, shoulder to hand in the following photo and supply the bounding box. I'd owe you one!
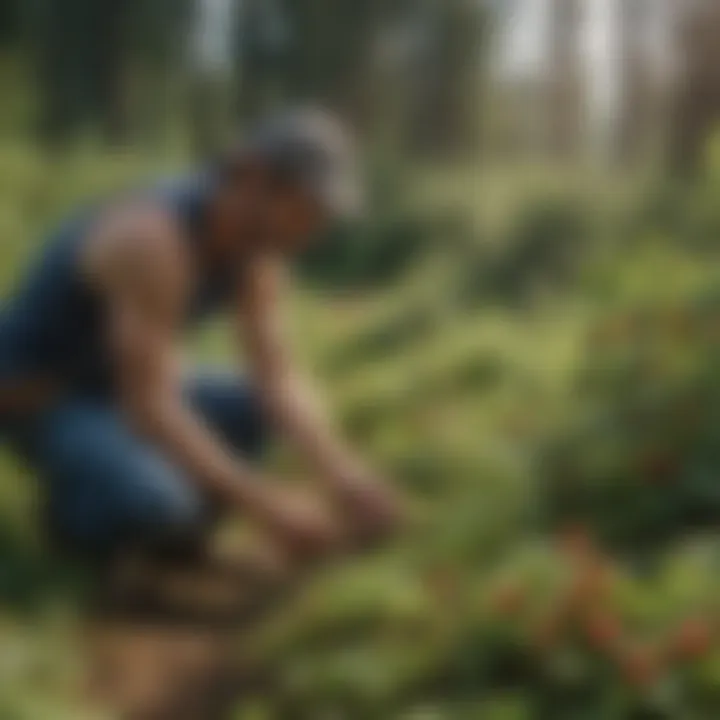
[85,207,336,556]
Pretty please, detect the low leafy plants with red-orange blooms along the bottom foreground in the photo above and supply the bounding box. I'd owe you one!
[240,528,720,720]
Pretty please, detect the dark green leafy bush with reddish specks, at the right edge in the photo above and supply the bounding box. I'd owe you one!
[545,284,720,551]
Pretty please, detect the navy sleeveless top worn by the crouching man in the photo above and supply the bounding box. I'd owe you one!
[0,175,232,394]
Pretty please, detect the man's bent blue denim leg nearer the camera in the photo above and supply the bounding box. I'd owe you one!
[31,400,206,548]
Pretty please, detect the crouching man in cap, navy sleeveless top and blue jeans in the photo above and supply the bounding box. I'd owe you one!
[0,110,399,600]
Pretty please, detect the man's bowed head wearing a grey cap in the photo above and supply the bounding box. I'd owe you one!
[214,109,362,252]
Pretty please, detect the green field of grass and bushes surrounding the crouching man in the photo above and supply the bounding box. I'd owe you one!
[0,144,720,720]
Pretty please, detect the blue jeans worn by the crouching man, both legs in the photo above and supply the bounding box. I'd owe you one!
[0,375,267,550]
